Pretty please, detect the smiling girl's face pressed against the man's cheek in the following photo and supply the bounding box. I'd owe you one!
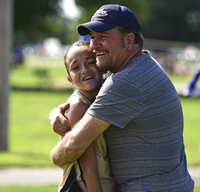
[66,45,103,92]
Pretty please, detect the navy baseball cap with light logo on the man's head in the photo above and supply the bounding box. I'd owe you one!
[77,4,141,35]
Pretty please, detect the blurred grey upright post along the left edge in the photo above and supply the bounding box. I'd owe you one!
[0,0,13,151]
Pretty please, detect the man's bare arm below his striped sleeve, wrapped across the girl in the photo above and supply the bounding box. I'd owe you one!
[51,113,110,165]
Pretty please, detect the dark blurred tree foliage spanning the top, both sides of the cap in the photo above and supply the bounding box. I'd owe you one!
[13,0,200,44]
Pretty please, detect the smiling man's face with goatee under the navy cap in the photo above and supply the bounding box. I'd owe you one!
[90,29,127,73]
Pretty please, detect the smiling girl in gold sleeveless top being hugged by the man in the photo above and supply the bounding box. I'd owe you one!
[51,41,116,192]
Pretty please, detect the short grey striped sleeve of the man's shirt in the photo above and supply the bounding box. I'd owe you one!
[87,75,143,128]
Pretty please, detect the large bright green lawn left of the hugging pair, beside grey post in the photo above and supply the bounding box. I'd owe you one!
[0,91,71,167]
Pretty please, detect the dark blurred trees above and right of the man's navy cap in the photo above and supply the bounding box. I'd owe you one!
[76,0,200,42]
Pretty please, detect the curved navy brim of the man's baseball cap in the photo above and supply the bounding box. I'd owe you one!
[77,21,117,35]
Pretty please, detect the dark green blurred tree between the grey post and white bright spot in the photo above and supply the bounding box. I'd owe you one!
[14,0,68,44]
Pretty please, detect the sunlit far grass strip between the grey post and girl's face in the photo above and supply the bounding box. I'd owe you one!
[10,65,72,89]
